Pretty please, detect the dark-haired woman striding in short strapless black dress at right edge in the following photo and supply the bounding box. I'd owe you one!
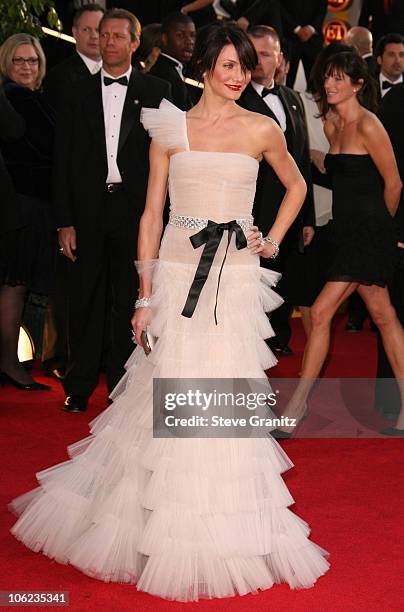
[278,52,404,437]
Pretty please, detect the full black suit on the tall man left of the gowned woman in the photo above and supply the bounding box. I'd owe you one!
[54,70,171,397]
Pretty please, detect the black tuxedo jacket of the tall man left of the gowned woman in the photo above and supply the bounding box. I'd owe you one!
[54,69,171,228]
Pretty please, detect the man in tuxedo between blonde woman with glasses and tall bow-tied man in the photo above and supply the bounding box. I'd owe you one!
[44,4,104,110]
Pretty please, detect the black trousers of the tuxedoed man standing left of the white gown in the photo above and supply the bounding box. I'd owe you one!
[63,189,139,397]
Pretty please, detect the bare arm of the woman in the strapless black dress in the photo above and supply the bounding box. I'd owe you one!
[359,114,403,217]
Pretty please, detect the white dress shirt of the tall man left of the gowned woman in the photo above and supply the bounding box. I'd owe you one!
[101,66,132,183]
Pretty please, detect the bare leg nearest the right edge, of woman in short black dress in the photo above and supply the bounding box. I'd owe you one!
[358,285,404,429]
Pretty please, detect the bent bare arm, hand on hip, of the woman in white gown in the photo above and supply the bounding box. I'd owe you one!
[249,119,307,257]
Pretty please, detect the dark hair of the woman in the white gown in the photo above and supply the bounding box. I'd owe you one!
[189,23,258,81]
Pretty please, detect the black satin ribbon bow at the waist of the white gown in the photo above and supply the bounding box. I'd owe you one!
[181,221,247,325]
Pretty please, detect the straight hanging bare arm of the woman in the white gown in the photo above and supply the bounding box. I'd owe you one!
[138,141,169,297]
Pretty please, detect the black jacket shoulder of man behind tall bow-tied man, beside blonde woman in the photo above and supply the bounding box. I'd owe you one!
[43,52,92,110]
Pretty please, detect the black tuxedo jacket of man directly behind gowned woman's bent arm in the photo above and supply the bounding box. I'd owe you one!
[239,83,315,251]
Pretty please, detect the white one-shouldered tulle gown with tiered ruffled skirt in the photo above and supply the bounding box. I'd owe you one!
[10,100,329,601]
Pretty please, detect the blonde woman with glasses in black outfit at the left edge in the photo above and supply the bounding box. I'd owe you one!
[0,34,55,391]
